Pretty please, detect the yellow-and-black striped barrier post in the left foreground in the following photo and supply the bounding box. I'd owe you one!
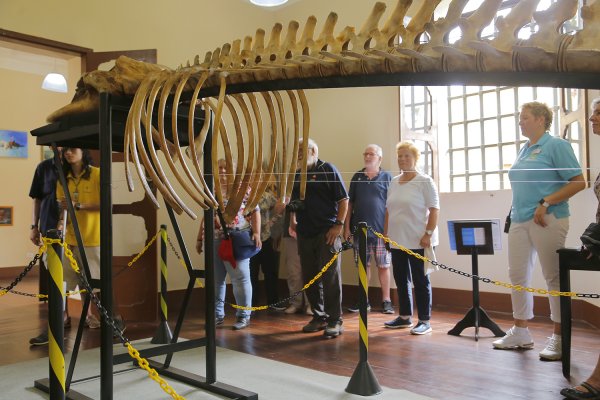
[47,229,65,400]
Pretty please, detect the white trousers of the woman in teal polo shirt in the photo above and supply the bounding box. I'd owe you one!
[508,214,569,322]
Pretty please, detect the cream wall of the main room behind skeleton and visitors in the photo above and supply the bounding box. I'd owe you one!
[0,0,600,310]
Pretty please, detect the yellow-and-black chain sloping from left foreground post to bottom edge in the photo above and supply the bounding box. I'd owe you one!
[42,238,185,400]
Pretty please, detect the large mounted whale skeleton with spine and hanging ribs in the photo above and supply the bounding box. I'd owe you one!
[43,0,600,222]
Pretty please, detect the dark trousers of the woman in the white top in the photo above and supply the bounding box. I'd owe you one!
[392,249,431,321]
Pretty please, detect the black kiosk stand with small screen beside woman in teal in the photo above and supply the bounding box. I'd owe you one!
[448,220,505,341]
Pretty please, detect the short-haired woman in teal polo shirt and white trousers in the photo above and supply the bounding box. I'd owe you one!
[493,102,585,360]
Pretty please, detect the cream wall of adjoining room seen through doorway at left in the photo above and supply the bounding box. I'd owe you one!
[0,40,81,268]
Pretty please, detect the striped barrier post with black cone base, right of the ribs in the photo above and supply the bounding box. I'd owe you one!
[346,222,383,396]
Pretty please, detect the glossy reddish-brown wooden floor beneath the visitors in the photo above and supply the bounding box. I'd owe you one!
[0,278,600,400]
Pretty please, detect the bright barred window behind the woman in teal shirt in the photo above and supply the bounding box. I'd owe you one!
[400,0,588,192]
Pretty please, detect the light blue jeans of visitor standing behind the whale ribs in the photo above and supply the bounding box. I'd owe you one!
[215,238,252,318]
